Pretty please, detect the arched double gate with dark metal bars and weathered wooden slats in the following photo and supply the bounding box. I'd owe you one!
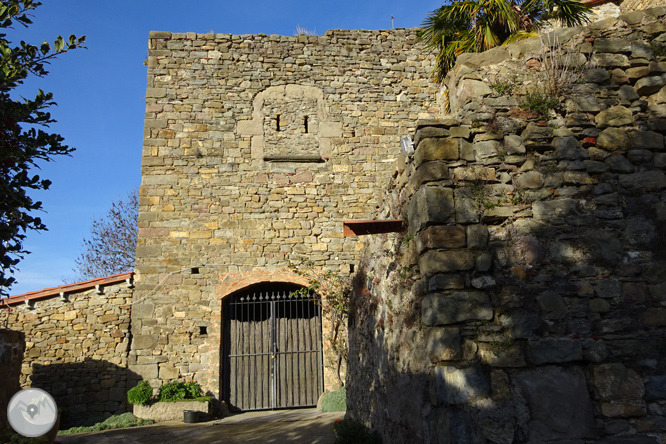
[224,285,323,410]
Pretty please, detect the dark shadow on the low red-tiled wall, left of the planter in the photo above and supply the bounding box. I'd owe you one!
[29,359,140,429]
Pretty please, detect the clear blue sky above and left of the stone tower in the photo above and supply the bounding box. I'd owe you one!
[7,0,442,294]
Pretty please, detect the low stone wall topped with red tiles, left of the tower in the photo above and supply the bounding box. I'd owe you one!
[0,273,136,427]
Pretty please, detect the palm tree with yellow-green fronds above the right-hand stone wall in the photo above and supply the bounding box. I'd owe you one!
[419,0,590,82]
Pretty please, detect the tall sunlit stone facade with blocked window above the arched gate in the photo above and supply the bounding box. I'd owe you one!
[130,29,439,397]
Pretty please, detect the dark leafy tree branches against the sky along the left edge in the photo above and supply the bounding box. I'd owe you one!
[0,0,85,296]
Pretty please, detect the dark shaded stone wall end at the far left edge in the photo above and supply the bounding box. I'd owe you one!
[0,330,25,432]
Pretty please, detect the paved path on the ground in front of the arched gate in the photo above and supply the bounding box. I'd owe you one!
[56,409,344,444]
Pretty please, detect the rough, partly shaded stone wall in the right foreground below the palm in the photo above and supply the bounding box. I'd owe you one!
[347,8,666,444]
